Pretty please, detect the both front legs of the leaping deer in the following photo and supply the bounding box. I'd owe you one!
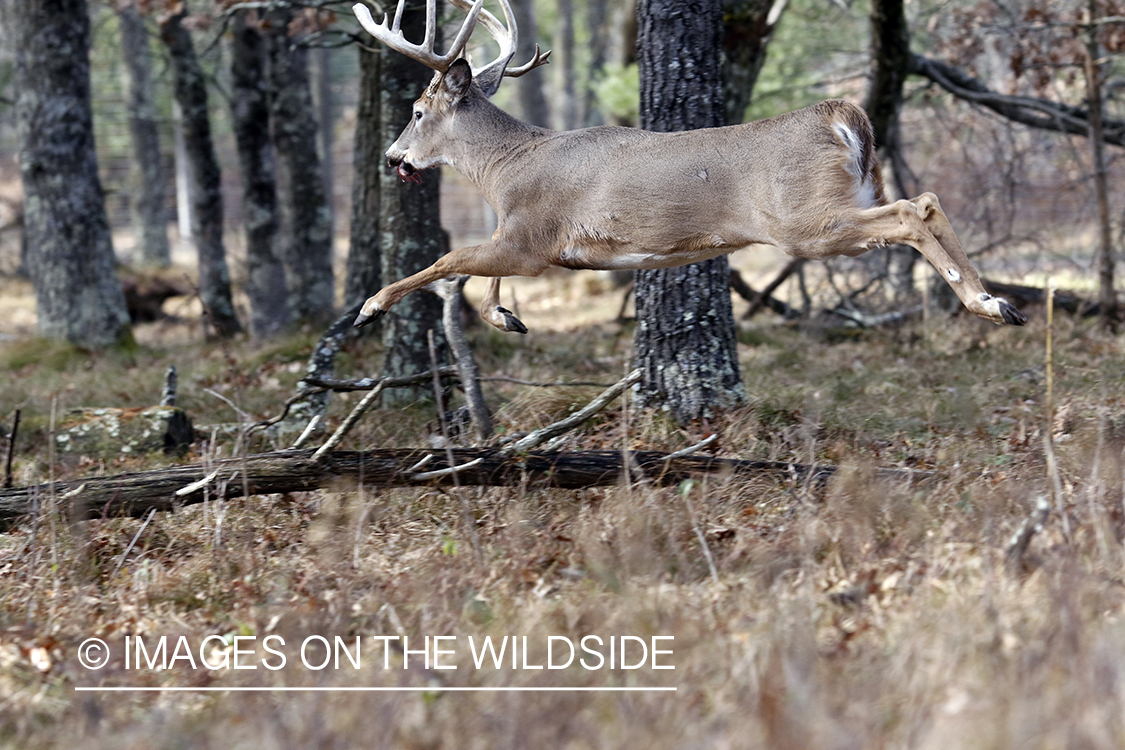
[352,242,547,333]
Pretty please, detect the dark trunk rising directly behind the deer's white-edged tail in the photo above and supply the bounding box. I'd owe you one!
[864,0,918,299]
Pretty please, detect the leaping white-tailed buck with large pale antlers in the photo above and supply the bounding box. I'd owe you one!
[353,0,1026,333]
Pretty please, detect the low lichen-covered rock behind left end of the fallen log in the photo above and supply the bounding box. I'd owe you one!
[55,406,195,459]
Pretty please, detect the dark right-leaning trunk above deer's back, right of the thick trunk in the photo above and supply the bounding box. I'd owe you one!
[722,0,785,125]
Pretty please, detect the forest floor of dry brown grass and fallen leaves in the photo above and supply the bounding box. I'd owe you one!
[0,259,1125,749]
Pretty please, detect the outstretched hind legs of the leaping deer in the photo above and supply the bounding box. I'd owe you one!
[858,192,1027,325]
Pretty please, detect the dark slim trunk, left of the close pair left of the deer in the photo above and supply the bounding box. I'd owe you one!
[231,10,289,338]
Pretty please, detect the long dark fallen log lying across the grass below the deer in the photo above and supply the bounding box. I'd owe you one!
[0,448,928,530]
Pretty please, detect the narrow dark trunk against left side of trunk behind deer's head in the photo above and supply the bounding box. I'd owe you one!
[344,45,387,314]
